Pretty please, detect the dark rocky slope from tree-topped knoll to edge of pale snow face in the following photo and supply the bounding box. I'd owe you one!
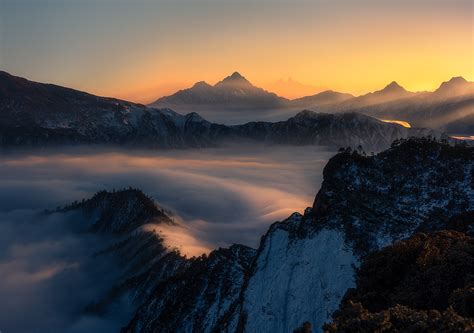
[45,188,256,332]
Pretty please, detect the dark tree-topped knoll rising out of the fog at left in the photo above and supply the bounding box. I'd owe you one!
[45,188,188,315]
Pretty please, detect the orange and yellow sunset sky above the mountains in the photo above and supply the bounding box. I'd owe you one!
[0,0,474,103]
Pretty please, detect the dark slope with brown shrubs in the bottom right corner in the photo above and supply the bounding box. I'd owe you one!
[325,231,474,333]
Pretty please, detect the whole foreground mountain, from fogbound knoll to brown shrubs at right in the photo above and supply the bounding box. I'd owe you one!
[38,138,474,333]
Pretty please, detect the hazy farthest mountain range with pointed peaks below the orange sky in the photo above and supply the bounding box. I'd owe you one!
[150,72,474,130]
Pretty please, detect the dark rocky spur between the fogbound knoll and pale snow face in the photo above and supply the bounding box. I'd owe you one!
[123,245,255,332]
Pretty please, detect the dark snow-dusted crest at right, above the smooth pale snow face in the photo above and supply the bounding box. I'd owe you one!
[313,139,474,253]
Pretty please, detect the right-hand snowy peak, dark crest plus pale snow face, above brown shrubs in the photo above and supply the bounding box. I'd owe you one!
[234,140,474,332]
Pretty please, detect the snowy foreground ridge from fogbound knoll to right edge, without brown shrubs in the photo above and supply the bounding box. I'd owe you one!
[24,139,474,333]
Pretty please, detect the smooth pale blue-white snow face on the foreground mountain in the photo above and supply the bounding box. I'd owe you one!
[243,228,358,332]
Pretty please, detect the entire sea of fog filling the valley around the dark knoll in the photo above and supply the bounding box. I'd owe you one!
[0,146,334,332]
